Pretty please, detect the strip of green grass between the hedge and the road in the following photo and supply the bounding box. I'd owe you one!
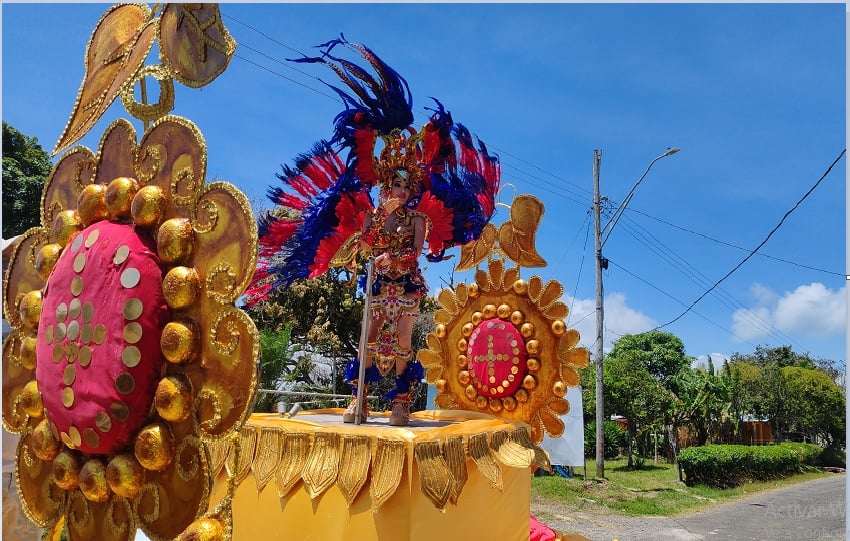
[531,459,830,516]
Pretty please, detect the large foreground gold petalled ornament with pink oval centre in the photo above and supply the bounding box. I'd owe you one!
[2,4,259,541]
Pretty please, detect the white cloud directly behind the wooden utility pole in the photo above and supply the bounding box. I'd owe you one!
[566,293,656,353]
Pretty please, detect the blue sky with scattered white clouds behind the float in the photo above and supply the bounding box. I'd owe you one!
[2,3,847,370]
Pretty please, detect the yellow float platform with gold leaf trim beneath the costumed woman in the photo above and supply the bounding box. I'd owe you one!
[211,410,546,541]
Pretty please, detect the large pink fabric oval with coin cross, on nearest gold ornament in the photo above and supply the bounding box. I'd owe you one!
[36,221,169,454]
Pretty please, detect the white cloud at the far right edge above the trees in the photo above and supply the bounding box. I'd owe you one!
[732,282,847,340]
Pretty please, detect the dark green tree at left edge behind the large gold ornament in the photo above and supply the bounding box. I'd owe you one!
[3,121,52,239]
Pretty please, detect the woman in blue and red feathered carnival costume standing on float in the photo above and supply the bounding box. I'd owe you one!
[246,37,500,426]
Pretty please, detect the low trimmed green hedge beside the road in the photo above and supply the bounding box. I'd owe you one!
[678,443,822,488]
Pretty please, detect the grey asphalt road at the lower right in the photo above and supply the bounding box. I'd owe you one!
[532,473,846,541]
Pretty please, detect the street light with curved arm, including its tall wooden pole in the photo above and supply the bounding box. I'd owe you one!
[593,147,679,479]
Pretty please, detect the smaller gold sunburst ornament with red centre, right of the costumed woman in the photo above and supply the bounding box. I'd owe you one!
[419,195,590,443]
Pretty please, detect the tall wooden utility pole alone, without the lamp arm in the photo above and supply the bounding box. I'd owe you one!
[593,150,608,479]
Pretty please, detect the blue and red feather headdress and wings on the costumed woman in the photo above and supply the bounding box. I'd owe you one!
[246,36,500,304]
